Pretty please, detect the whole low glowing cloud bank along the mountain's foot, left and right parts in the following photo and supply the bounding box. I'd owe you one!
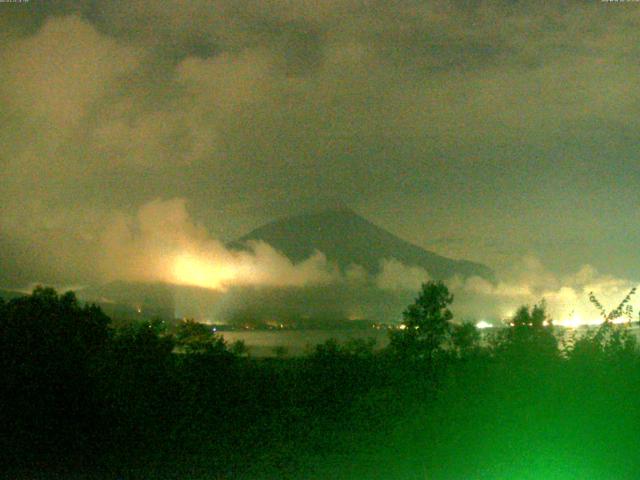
[100,199,637,326]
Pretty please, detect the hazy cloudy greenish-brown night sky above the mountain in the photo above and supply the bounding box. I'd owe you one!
[0,0,640,322]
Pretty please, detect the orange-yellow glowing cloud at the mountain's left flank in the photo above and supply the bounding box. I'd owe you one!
[100,199,340,291]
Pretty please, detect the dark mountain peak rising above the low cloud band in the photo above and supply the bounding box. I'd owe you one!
[228,207,494,280]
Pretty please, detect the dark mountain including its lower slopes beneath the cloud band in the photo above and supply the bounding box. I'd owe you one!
[79,207,494,326]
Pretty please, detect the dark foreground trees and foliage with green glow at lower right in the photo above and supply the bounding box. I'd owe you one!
[0,283,640,480]
